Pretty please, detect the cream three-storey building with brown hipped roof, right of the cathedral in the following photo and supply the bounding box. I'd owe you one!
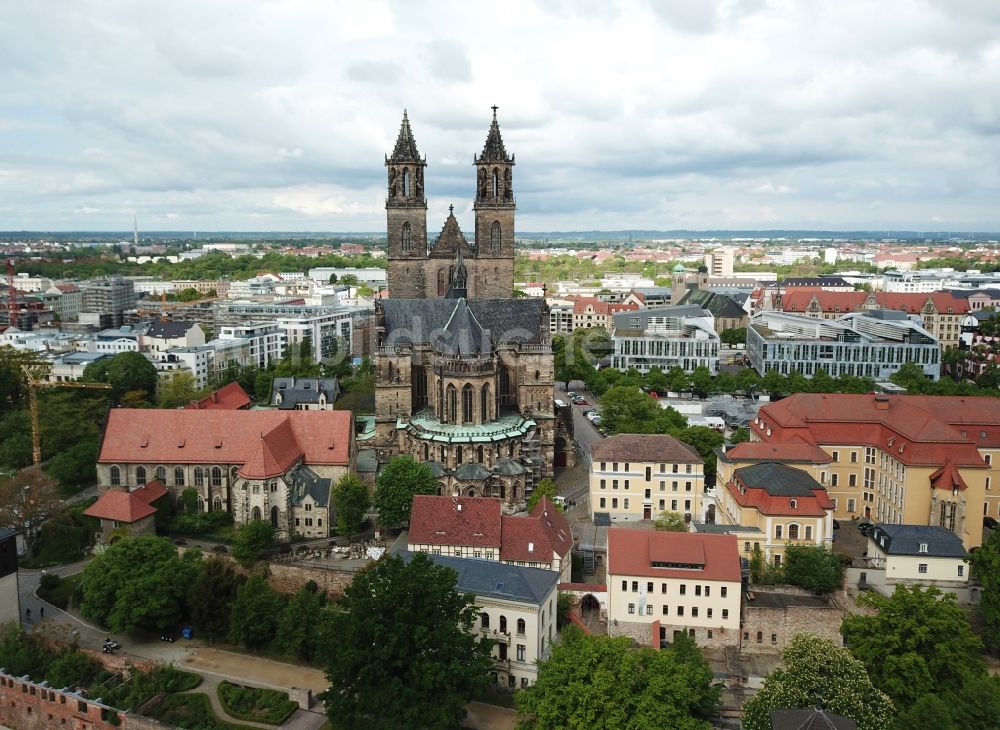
[590,433,705,522]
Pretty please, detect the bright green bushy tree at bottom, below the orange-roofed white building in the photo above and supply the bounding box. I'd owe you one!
[514,627,719,730]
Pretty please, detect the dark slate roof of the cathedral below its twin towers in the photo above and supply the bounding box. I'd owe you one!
[379,298,549,352]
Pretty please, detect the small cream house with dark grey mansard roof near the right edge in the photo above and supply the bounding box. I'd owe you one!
[860,522,969,595]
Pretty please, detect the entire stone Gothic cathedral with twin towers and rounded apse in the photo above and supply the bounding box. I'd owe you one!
[374,107,573,512]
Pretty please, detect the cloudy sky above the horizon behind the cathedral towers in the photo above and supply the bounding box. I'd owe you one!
[0,0,1000,234]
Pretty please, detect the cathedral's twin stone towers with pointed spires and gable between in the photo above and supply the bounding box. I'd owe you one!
[385,107,516,299]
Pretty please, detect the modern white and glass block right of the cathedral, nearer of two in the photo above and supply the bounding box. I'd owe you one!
[612,306,719,375]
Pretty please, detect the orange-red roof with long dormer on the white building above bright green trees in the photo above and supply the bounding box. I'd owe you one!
[608,528,740,583]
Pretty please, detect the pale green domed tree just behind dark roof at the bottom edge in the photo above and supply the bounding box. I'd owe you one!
[743,634,895,730]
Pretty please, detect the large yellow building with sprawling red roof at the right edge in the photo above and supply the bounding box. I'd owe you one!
[750,393,1000,548]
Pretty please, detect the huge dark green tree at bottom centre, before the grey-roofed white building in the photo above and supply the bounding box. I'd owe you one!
[320,553,493,730]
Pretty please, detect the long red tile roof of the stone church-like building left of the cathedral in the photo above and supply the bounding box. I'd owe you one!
[98,408,354,466]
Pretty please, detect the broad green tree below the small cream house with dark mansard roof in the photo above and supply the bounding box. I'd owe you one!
[840,585,986,707]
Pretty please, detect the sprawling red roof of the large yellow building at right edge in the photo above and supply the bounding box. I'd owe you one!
[751,393,1000,468]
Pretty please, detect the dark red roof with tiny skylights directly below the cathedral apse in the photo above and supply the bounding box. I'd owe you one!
[409,494,501,548]
